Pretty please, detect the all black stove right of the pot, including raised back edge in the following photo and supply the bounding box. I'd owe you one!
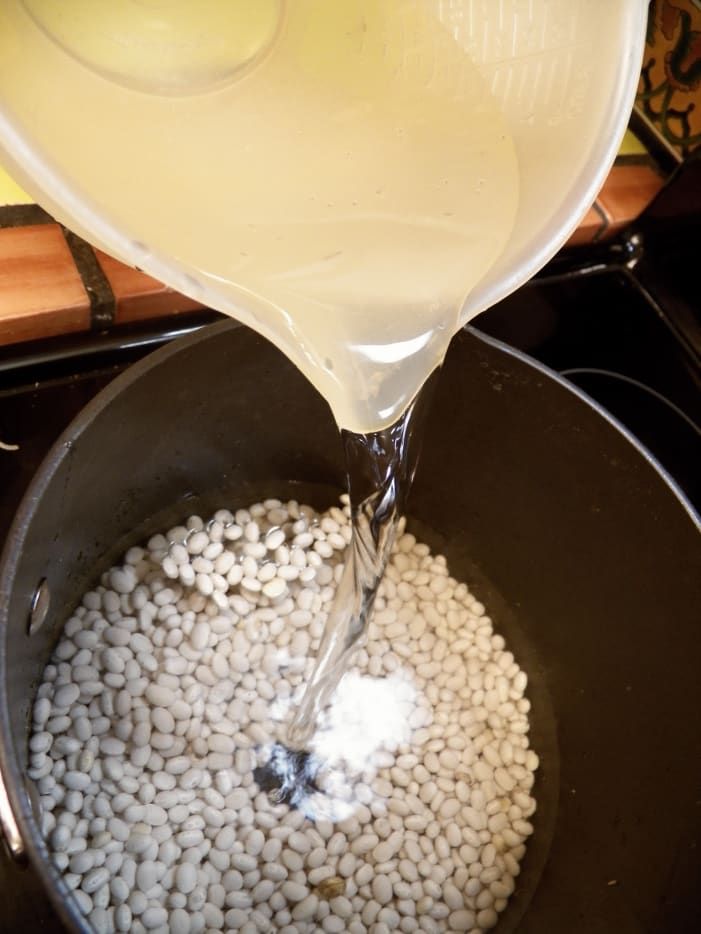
[475,150,701,512]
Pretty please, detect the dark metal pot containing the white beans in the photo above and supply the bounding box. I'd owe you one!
[0,322,701,934]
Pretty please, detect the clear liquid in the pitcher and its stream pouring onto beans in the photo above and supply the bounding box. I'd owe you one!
[0,0,518,744]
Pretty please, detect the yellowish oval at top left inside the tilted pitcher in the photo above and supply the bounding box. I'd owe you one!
[22,0,282,95]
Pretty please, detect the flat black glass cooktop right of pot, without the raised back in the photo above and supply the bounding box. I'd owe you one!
[475,267,701,511]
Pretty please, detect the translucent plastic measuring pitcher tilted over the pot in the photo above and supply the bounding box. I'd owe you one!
[0,0,647,428]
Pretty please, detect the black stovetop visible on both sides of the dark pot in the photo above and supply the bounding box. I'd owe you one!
[0,158,701,931]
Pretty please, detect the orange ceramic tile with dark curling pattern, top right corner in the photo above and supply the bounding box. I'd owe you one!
[637,0,701,156]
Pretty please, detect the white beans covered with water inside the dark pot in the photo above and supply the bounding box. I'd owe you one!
[29,500,538,934]
